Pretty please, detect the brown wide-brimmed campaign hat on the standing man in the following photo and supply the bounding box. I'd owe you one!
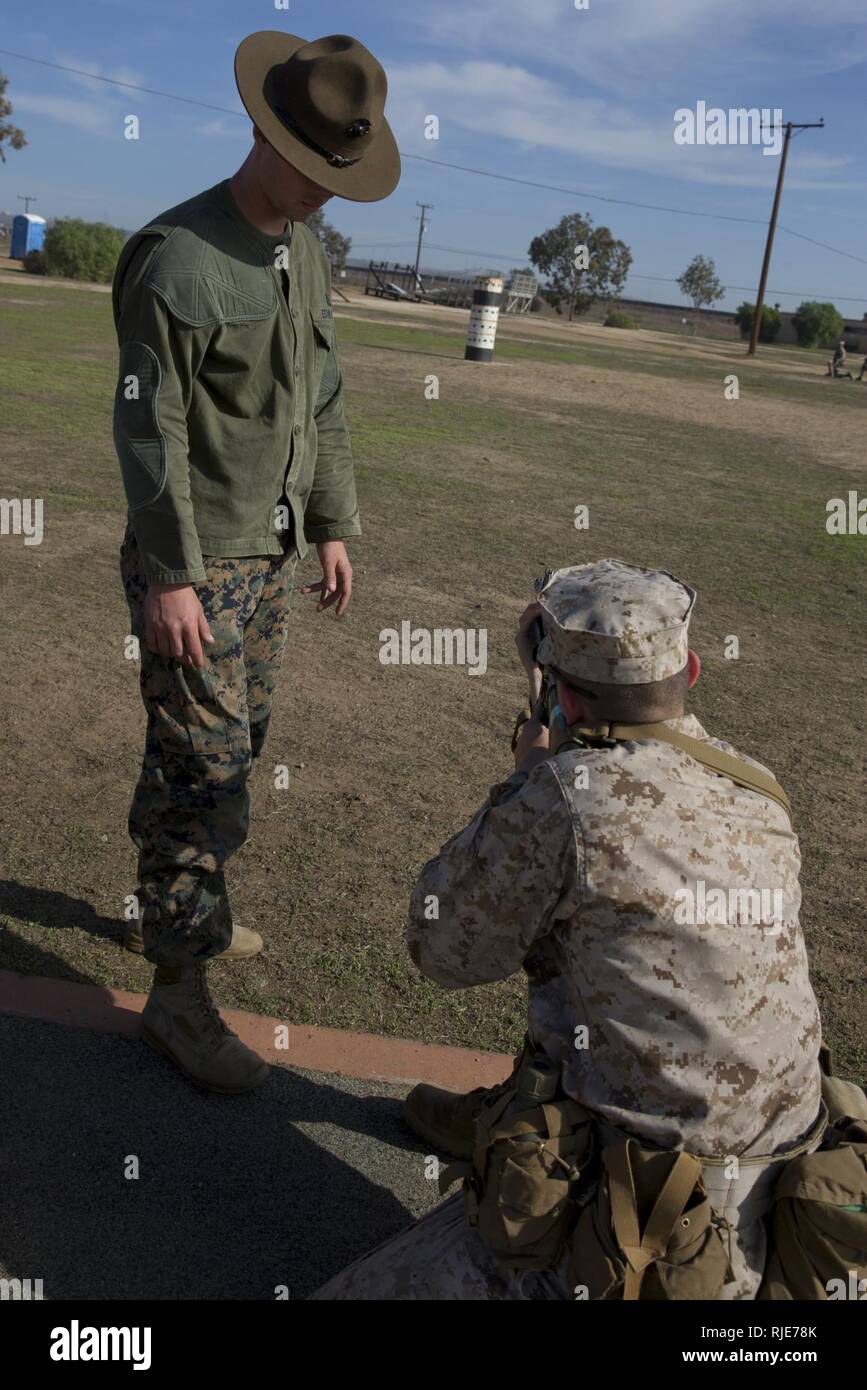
[235,29,400,203]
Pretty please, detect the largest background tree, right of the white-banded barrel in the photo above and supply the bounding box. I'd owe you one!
[528,213,632,322]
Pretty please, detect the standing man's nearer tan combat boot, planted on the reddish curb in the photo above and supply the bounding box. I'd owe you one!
[142,962,268,1095]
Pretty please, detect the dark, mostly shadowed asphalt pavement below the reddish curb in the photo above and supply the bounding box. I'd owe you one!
[0,1016,436,1300]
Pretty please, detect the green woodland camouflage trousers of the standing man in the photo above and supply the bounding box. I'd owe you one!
[121,527,297,965]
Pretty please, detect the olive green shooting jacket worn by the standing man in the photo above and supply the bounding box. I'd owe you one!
[113,181,361,584]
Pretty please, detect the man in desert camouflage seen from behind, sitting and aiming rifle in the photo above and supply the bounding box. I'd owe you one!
[314,560,825,1301]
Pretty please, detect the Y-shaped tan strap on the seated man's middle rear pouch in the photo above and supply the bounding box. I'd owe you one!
[604,1140,702,1302]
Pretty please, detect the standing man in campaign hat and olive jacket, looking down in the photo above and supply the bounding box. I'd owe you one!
[114,31,400,1093]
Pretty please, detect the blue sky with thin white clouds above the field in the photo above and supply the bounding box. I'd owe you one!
[0,0,867,317]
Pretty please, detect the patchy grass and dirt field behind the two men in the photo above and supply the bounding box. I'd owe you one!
[0,275,867,1079]
